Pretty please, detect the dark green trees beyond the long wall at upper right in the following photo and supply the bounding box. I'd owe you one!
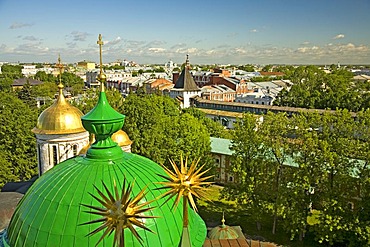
[274,65,370,112]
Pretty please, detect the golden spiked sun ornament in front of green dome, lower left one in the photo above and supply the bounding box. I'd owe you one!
[81,179,158,247]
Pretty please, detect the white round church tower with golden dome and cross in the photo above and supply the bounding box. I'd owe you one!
[32,57,89,176]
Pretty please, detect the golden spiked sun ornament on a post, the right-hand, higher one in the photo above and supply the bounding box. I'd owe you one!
[158,157,213,226]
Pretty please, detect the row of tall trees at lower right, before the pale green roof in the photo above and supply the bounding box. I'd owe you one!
[223,110,370,246]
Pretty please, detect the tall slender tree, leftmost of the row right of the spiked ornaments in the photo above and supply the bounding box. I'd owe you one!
[222,113,269,230]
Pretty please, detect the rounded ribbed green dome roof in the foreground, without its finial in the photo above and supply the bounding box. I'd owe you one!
[0,152,206,247]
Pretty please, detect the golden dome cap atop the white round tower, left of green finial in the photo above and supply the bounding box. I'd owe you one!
[32,84,86,134]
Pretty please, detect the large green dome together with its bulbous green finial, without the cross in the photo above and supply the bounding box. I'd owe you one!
[0,92,206,247]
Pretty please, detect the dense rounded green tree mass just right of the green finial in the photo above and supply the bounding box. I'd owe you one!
[121,94,210,168]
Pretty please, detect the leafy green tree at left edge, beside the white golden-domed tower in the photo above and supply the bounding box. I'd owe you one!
[0,92,38,184]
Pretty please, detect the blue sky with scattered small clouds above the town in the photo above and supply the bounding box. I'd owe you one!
[0,0,370,64]
